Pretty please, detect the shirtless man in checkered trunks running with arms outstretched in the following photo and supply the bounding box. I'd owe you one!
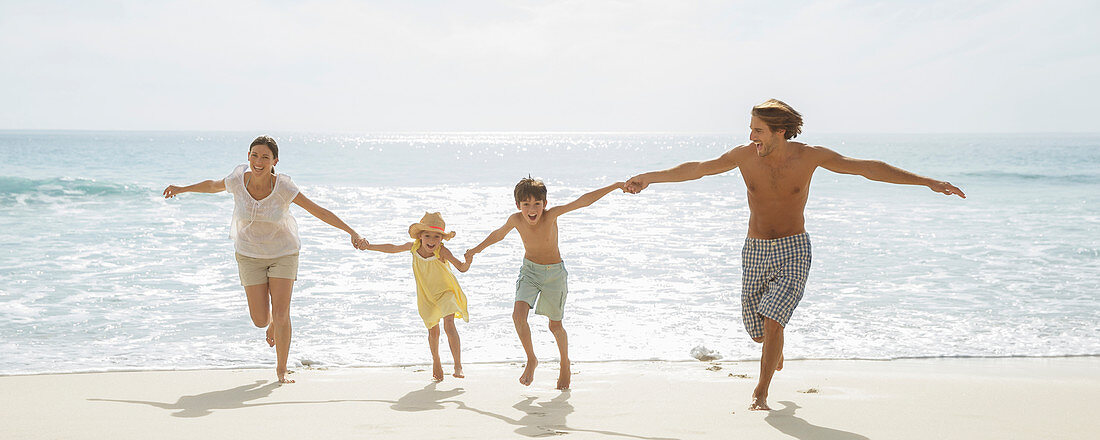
[624,99,966,410]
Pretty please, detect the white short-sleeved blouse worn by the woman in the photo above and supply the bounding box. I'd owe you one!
[226,164,301,259]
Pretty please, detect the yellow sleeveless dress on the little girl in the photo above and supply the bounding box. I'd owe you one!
[413,239,470,329]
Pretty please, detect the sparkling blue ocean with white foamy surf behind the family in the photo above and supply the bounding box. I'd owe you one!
[0,131,1100,374]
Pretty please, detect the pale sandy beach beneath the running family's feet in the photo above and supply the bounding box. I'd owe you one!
[0,358,1100,439]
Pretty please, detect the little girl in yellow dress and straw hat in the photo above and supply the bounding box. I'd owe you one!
[364,212,470,382]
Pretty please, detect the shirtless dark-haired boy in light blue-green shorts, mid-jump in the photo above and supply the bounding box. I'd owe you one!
[465,177,624,389]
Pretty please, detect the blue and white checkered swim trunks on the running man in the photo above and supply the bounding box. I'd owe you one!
[741,232,810,338]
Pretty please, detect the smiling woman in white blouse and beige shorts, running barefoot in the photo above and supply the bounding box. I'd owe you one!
[164,136,367,384]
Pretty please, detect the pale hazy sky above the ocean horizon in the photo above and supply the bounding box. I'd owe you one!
[0,0,1100,133]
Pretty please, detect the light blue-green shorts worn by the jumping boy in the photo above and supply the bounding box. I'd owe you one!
[516,259,569,321]
